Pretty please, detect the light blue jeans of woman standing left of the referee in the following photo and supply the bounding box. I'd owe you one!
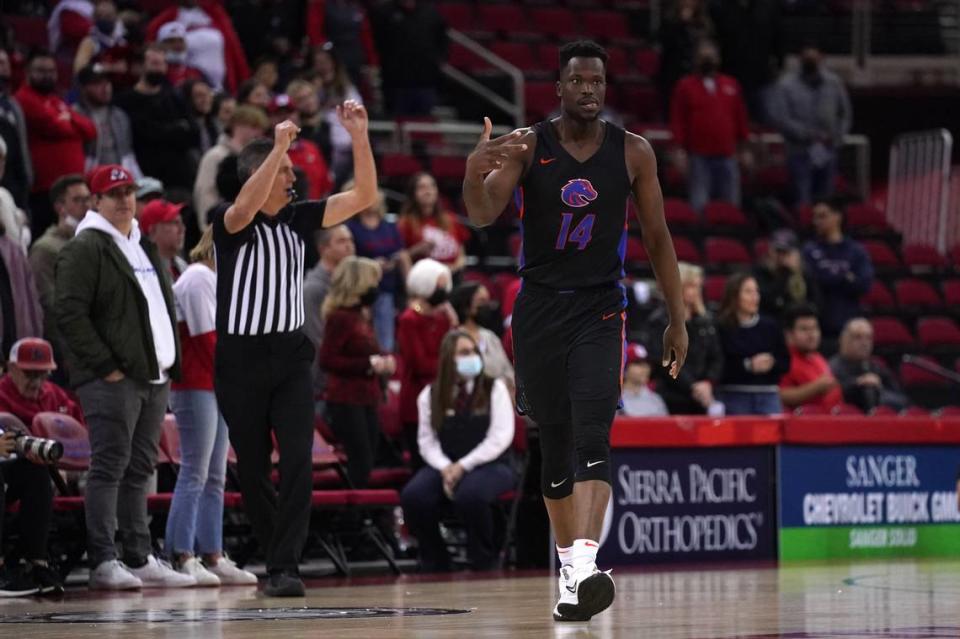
[164,391,229,557]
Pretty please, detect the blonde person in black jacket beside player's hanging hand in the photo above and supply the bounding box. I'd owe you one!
[649,262,723,416]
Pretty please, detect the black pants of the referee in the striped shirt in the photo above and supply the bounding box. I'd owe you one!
[214,331,315,571]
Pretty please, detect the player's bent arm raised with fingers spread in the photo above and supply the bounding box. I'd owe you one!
[463,117,536,226]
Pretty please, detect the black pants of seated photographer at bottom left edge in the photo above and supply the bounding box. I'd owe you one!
[0,459,53,559]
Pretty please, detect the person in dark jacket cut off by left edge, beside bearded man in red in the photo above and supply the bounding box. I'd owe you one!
[0,49,33,209]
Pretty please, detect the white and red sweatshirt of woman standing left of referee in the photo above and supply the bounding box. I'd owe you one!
[171,263,217,391]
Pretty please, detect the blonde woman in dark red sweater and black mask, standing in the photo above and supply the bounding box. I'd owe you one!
[320,256,397,488]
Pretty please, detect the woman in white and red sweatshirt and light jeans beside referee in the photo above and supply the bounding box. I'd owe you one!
[164,227,257,586]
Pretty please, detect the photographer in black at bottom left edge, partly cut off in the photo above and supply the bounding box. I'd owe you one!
[0,412,63,597]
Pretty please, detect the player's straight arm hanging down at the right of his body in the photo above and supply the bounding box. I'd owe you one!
[626,133,688,379]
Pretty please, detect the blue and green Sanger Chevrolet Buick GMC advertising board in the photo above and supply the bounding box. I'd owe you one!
[778,445,960,559]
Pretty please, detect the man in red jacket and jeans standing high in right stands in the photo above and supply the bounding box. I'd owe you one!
[670,40,751,211]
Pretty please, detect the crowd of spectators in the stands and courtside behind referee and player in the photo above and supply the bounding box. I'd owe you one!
[0,0,956,594]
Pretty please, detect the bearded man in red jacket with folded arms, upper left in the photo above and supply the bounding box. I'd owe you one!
[16,53,97,237]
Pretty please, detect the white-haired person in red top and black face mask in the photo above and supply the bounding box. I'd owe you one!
[397,259,457,468]
